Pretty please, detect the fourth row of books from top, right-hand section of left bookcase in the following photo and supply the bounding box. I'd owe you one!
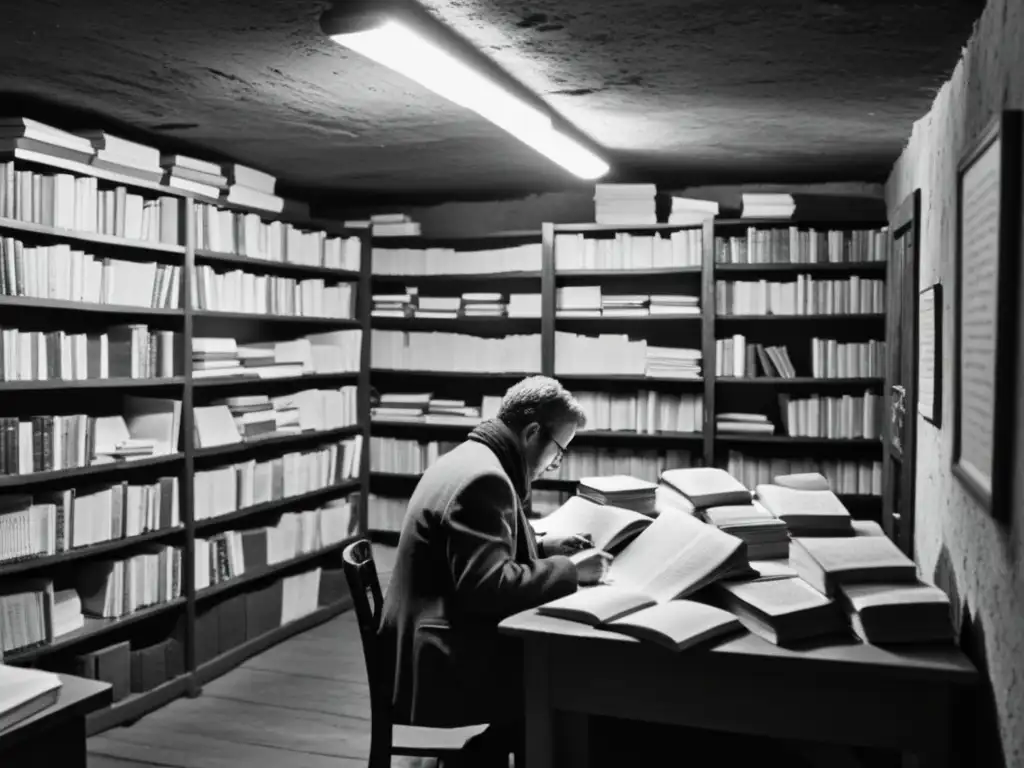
[194,386,358,449]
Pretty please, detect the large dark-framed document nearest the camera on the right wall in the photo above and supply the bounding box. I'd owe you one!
[953,112,1024,519]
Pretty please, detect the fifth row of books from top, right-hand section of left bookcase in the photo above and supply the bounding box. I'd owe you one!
[193,437,362,520]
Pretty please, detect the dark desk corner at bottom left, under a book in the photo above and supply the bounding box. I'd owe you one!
[0,675,112,768]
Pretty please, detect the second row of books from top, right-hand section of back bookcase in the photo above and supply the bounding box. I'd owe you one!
[715,274,886,315]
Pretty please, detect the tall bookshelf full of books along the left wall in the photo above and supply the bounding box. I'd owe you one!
[0,148,371,733]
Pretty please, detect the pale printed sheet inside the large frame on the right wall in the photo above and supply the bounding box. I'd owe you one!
[956,138,1003,494]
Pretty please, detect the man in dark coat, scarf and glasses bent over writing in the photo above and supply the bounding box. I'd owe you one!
[381,376,607,766]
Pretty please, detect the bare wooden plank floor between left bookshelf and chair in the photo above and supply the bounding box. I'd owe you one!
[88,549,401,768]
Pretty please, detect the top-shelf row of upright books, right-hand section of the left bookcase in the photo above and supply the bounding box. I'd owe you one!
[194,203,362,271]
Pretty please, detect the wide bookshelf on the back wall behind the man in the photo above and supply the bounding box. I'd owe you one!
[368,218,890,534]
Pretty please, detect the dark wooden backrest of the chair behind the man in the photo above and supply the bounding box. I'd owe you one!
[341,539,393,727]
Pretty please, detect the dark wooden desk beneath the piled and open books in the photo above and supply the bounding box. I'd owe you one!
[501,610,978,768]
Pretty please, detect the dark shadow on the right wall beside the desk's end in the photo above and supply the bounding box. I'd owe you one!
[932,546,1006,768]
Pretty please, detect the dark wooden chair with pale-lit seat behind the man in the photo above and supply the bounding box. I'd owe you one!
[342,539,487,768]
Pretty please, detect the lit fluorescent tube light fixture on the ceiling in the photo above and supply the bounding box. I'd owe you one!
[328,17,609,179]
